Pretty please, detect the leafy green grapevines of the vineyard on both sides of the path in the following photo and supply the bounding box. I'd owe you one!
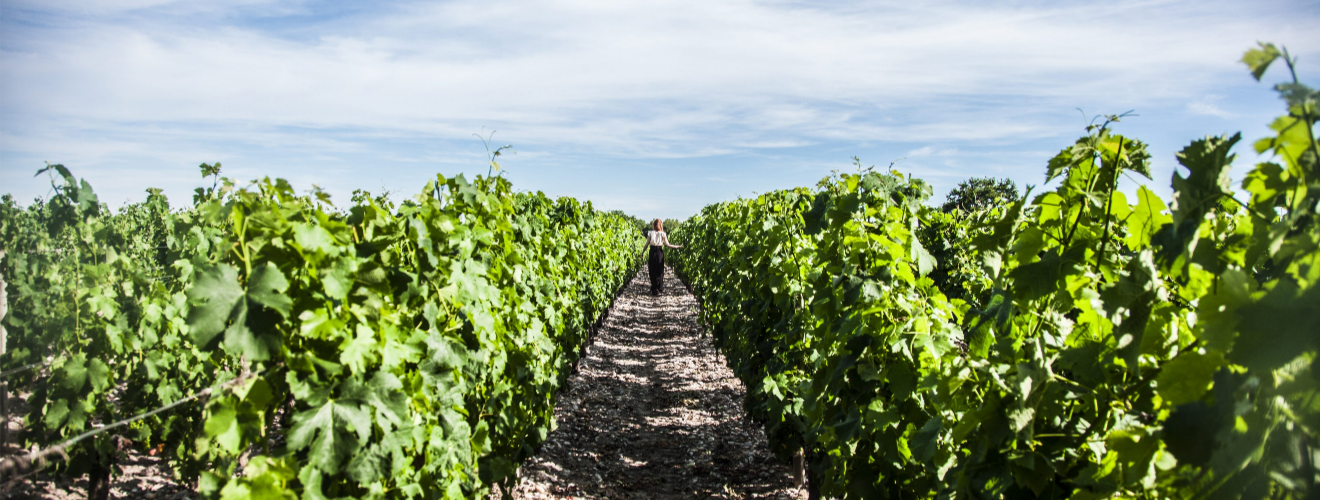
[0,44,1320,499]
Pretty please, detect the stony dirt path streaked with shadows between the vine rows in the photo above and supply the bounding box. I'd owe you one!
[504,269,807,499]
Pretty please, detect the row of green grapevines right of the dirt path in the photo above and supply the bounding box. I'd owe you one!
[672,45,1320,499]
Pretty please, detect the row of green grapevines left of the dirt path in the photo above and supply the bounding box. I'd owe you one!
[0,165,642,499]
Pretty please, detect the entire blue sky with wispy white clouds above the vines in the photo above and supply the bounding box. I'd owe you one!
[0,0,1320,219]
